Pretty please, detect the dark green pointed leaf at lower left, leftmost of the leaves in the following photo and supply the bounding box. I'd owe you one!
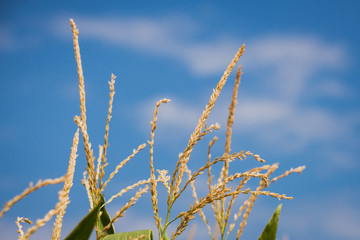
[65,203,101,240]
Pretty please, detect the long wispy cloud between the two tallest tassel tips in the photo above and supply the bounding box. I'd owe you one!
[53,16,242,75]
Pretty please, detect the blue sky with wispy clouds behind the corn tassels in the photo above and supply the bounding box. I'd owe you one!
[0,0,360,240]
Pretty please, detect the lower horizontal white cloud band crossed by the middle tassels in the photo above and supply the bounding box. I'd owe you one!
[137,93,354,151]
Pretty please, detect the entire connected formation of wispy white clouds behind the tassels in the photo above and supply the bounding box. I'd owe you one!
[51,16,360,170]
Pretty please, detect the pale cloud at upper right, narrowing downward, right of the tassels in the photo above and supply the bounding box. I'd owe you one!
[245,35,346,101]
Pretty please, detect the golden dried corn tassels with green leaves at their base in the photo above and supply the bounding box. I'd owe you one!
[0,19,305,240]
